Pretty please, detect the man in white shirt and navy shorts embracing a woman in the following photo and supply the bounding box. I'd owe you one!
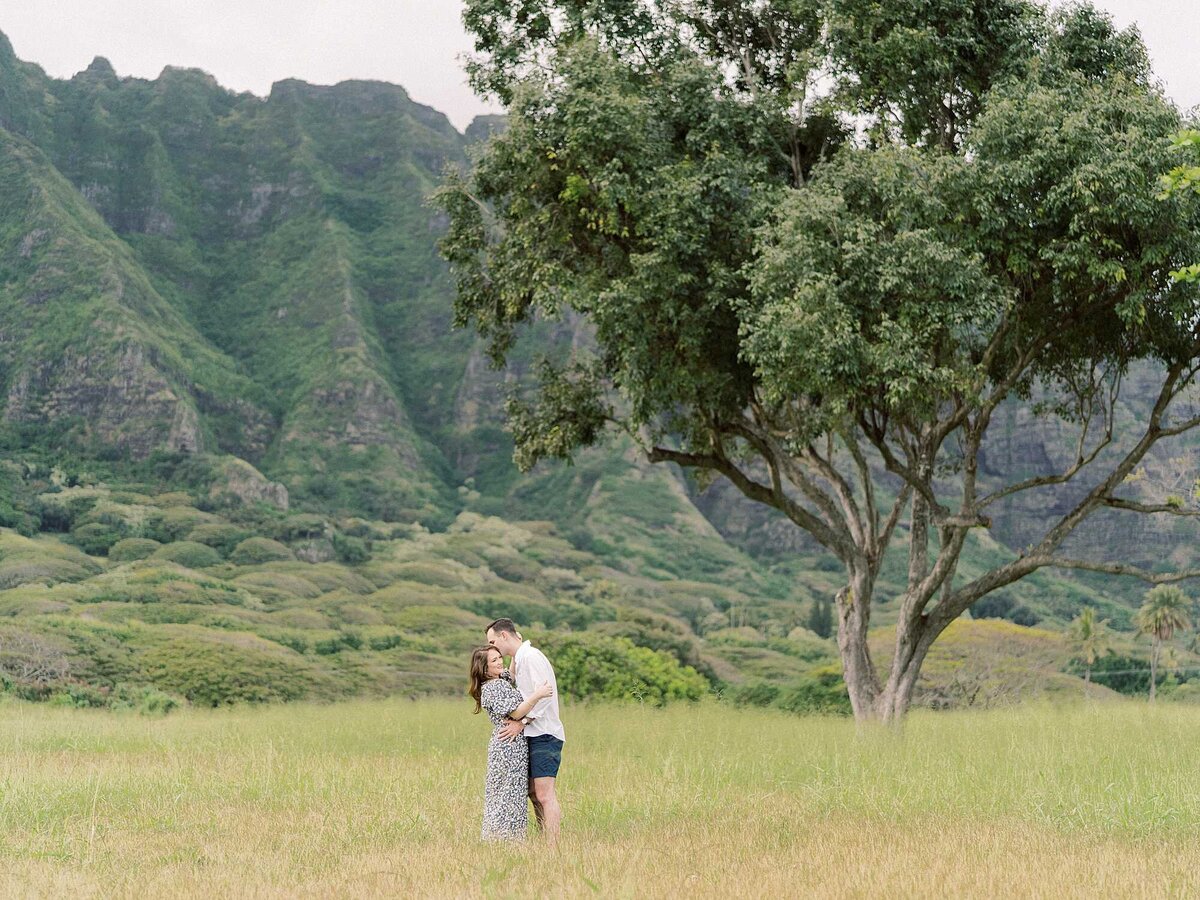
[487,619,566,844]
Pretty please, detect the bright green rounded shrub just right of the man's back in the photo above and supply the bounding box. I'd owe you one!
[542,635,708,704]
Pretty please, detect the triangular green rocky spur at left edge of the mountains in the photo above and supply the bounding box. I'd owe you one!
[0,125,272,456]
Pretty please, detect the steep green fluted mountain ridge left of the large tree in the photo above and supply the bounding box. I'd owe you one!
[0,33,469,518]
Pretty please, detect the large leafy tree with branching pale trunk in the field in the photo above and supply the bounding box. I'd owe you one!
[438,0,1200,720]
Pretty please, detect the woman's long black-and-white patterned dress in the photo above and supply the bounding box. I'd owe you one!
[479,673,529,840]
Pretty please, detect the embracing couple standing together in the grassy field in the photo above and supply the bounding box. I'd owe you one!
[467,619,566,842]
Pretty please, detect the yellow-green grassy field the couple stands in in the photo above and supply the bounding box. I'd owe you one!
[0,701,1200,898]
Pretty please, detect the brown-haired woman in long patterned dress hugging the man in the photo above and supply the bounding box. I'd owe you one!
[467,647,554,841]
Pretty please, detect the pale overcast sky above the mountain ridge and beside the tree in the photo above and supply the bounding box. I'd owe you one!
[0,0,1200,128]
